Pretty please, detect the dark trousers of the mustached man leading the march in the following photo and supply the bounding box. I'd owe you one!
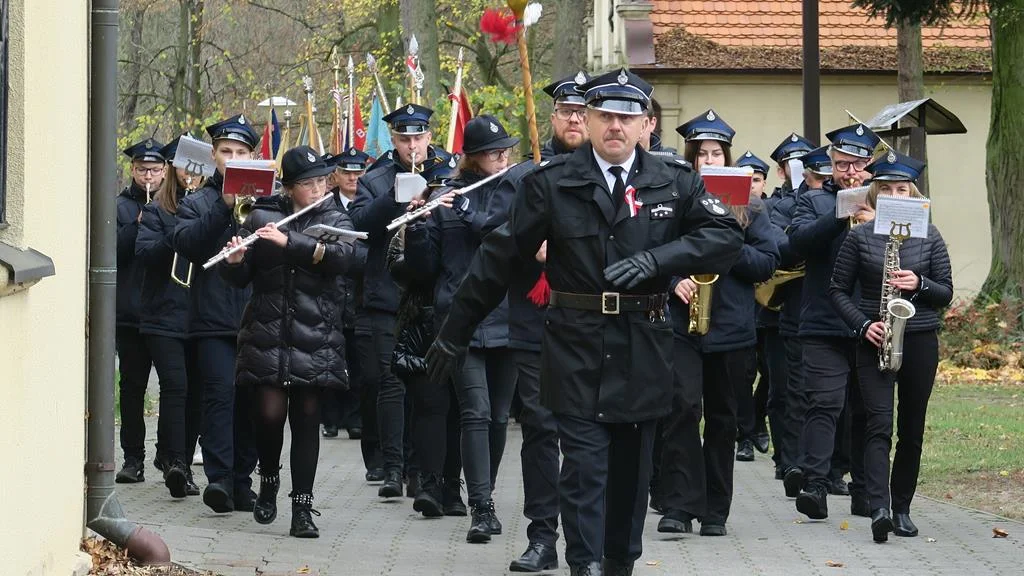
[555,414,655,567]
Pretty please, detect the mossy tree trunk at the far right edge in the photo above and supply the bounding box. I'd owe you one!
[981,0,1024,299]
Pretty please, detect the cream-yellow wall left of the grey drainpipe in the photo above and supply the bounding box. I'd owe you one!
[0,0,91,576]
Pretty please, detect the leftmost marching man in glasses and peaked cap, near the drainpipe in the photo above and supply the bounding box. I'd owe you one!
[115,138,166,484]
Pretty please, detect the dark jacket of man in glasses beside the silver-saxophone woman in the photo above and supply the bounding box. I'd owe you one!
[788,179,860,338]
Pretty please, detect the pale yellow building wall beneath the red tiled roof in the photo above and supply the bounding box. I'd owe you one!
[641,72,991,297]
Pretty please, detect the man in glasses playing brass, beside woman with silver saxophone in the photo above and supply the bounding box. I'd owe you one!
[782,124,880,520]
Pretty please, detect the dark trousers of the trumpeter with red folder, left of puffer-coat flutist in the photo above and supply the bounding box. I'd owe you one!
[189,336,258,487]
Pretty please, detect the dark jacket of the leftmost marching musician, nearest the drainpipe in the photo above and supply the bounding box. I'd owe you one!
[116,180,145,328]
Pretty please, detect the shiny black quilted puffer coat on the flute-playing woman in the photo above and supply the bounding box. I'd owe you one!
[220,196,353,387]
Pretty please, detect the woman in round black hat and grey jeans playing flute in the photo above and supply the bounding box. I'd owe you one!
[406,115,519,542]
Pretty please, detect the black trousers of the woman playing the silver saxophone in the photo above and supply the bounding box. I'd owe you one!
[857,330,939,513]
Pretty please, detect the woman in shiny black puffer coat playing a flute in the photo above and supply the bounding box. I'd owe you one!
[220,147,353,538]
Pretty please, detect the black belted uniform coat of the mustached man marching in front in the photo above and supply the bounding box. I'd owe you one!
[509,143,743,422]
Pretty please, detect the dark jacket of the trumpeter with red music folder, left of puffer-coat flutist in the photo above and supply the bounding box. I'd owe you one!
[174,172,251,338]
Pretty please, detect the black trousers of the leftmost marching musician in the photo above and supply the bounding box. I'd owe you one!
[114,326,151,461]
